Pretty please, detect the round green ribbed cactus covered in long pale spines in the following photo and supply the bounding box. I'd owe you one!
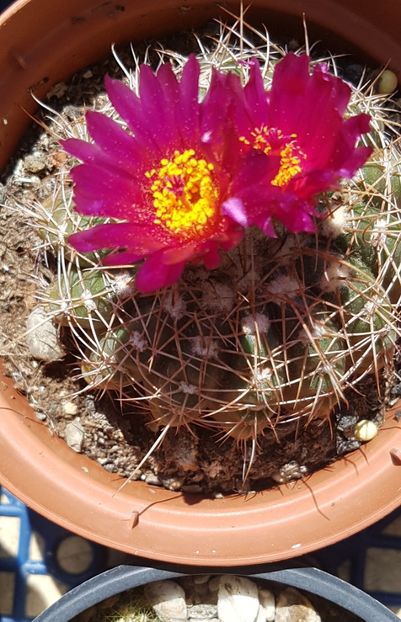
[24,15,401,472]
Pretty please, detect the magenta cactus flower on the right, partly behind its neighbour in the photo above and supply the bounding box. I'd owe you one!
[223,54,371,235]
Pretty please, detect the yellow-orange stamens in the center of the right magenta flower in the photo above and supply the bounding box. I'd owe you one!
[240,125,306,187]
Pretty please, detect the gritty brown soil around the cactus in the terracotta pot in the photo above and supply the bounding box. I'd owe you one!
[0,26,394,495]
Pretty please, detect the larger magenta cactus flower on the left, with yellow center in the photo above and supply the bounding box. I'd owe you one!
[63,56,242,292]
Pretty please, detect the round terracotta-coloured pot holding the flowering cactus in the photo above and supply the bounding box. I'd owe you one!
[0,0,401,566]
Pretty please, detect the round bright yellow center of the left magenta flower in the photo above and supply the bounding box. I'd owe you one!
[145,149,219,237]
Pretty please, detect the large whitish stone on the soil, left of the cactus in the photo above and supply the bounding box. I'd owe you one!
[25,307,64,362]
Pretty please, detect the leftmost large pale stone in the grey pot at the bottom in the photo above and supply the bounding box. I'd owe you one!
[144,581,188,622]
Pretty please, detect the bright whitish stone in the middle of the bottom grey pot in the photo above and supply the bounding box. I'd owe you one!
[217,575,259,622]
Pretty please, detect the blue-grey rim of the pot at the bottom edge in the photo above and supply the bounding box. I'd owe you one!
[33,566,399,622]
